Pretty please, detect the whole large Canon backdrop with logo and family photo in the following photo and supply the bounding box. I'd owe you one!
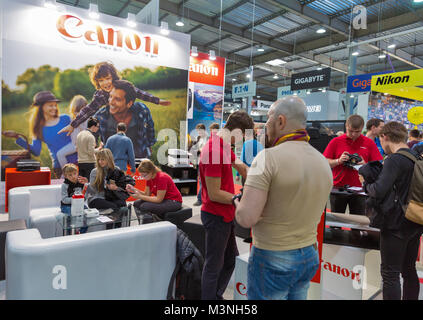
[1,0,191,179]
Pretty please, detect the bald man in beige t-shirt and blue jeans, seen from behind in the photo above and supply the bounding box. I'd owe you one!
[234,96,332,300]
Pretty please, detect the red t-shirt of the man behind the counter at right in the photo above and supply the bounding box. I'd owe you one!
[323,134,383,187]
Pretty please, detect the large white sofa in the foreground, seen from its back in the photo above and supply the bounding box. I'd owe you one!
[6,221,176,300]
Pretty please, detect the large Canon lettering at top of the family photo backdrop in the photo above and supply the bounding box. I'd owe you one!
[56,14,159,56]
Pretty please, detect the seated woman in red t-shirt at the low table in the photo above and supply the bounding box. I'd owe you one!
[126,159,182,219]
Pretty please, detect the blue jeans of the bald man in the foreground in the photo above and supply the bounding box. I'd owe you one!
[247,246,319,300]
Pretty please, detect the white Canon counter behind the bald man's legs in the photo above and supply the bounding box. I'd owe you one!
[234,212,381,300]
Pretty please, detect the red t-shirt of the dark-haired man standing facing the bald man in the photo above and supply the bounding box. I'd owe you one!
[199,134,236,222]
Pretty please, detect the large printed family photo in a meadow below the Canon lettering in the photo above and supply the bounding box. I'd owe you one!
[2,61,188,178]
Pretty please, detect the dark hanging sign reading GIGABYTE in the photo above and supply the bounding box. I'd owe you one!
[291,68,331,91]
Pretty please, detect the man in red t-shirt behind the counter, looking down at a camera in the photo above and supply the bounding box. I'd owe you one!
[323,114,383,214]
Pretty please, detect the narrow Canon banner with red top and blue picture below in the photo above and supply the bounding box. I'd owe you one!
[187,52,226,139]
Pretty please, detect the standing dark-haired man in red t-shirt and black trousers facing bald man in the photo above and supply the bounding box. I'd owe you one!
[199,111,254,300]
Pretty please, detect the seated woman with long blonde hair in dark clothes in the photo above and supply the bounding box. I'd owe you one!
[80,148,128,228]
